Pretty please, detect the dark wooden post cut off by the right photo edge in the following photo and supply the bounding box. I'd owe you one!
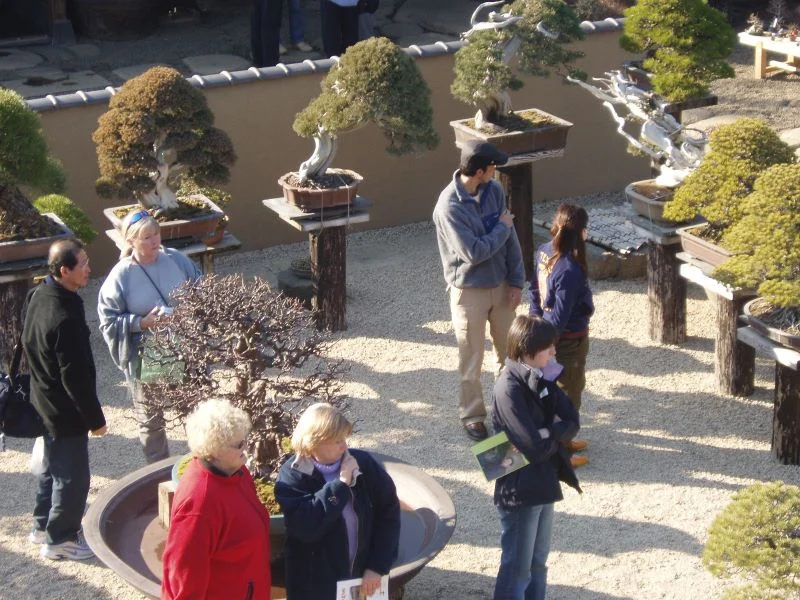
[772,363,800,465]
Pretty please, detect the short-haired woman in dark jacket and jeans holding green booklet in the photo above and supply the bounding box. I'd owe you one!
[492,315,581,600]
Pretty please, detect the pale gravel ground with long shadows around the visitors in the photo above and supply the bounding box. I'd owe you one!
[0,217,800,600]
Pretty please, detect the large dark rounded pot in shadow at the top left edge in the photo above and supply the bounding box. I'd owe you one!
[68,0,162,40]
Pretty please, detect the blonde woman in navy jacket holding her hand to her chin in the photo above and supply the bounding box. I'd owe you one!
[275,403,400,600]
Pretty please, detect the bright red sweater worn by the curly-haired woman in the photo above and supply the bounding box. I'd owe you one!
[161,458,271,600]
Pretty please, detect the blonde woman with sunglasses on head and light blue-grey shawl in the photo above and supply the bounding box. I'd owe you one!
[97,210,201,463]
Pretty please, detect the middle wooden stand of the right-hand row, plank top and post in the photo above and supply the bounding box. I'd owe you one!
[677,252,756,396]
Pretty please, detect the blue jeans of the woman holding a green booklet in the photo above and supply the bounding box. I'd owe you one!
[494,504,554,600]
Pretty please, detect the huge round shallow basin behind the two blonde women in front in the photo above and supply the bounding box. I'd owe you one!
[83,453,456,600]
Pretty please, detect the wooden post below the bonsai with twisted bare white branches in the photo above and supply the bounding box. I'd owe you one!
[647,241,686,345]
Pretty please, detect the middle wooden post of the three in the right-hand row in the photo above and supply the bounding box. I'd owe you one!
[714,295,756,396]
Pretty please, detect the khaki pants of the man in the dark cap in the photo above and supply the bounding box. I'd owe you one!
[450,283,515,425]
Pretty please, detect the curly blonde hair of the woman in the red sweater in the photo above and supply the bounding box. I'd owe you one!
[186,398,252,459]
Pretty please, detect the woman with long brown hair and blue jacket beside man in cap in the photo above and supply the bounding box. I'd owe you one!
[530,204,594,467]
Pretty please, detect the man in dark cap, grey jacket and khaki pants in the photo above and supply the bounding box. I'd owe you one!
[433,142,525,440]
